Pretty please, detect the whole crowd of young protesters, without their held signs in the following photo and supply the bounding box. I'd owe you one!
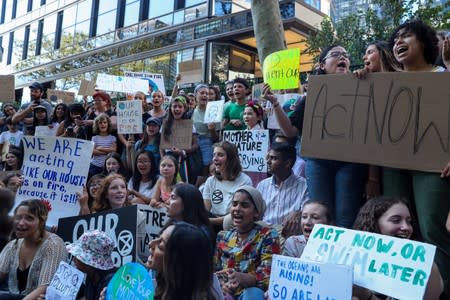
[0,20,450,300]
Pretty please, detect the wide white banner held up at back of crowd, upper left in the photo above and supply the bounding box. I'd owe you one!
[96,73,148,93]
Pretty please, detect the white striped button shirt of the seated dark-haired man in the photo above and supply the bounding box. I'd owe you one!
[256,173,309,225]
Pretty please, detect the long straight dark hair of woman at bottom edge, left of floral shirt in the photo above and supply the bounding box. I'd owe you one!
[162,222,217,300]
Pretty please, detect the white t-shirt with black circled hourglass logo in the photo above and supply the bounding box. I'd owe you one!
[203,172,252,216]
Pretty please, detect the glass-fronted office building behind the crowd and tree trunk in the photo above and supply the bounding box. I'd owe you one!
[0,0,325,98]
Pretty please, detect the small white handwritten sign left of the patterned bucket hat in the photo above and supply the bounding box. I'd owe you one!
[45,261,84,300]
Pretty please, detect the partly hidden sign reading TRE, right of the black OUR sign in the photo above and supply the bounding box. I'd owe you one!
[136,204,169,261]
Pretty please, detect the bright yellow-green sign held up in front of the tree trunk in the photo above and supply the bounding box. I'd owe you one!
[263,48,300,90]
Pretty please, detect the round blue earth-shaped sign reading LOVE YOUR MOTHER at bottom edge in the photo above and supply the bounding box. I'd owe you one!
[106,263,155,300]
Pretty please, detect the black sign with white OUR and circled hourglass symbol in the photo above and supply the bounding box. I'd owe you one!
[57,205,139,267]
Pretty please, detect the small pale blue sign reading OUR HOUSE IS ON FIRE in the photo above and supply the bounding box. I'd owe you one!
[116,100,142,134]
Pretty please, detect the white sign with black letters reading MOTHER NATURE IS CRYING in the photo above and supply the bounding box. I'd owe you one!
[223,130,269,173]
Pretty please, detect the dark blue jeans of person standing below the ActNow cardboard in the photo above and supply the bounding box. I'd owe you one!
[306,158,368,228]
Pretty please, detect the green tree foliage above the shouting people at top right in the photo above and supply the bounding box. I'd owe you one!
[306,0,450,67]
